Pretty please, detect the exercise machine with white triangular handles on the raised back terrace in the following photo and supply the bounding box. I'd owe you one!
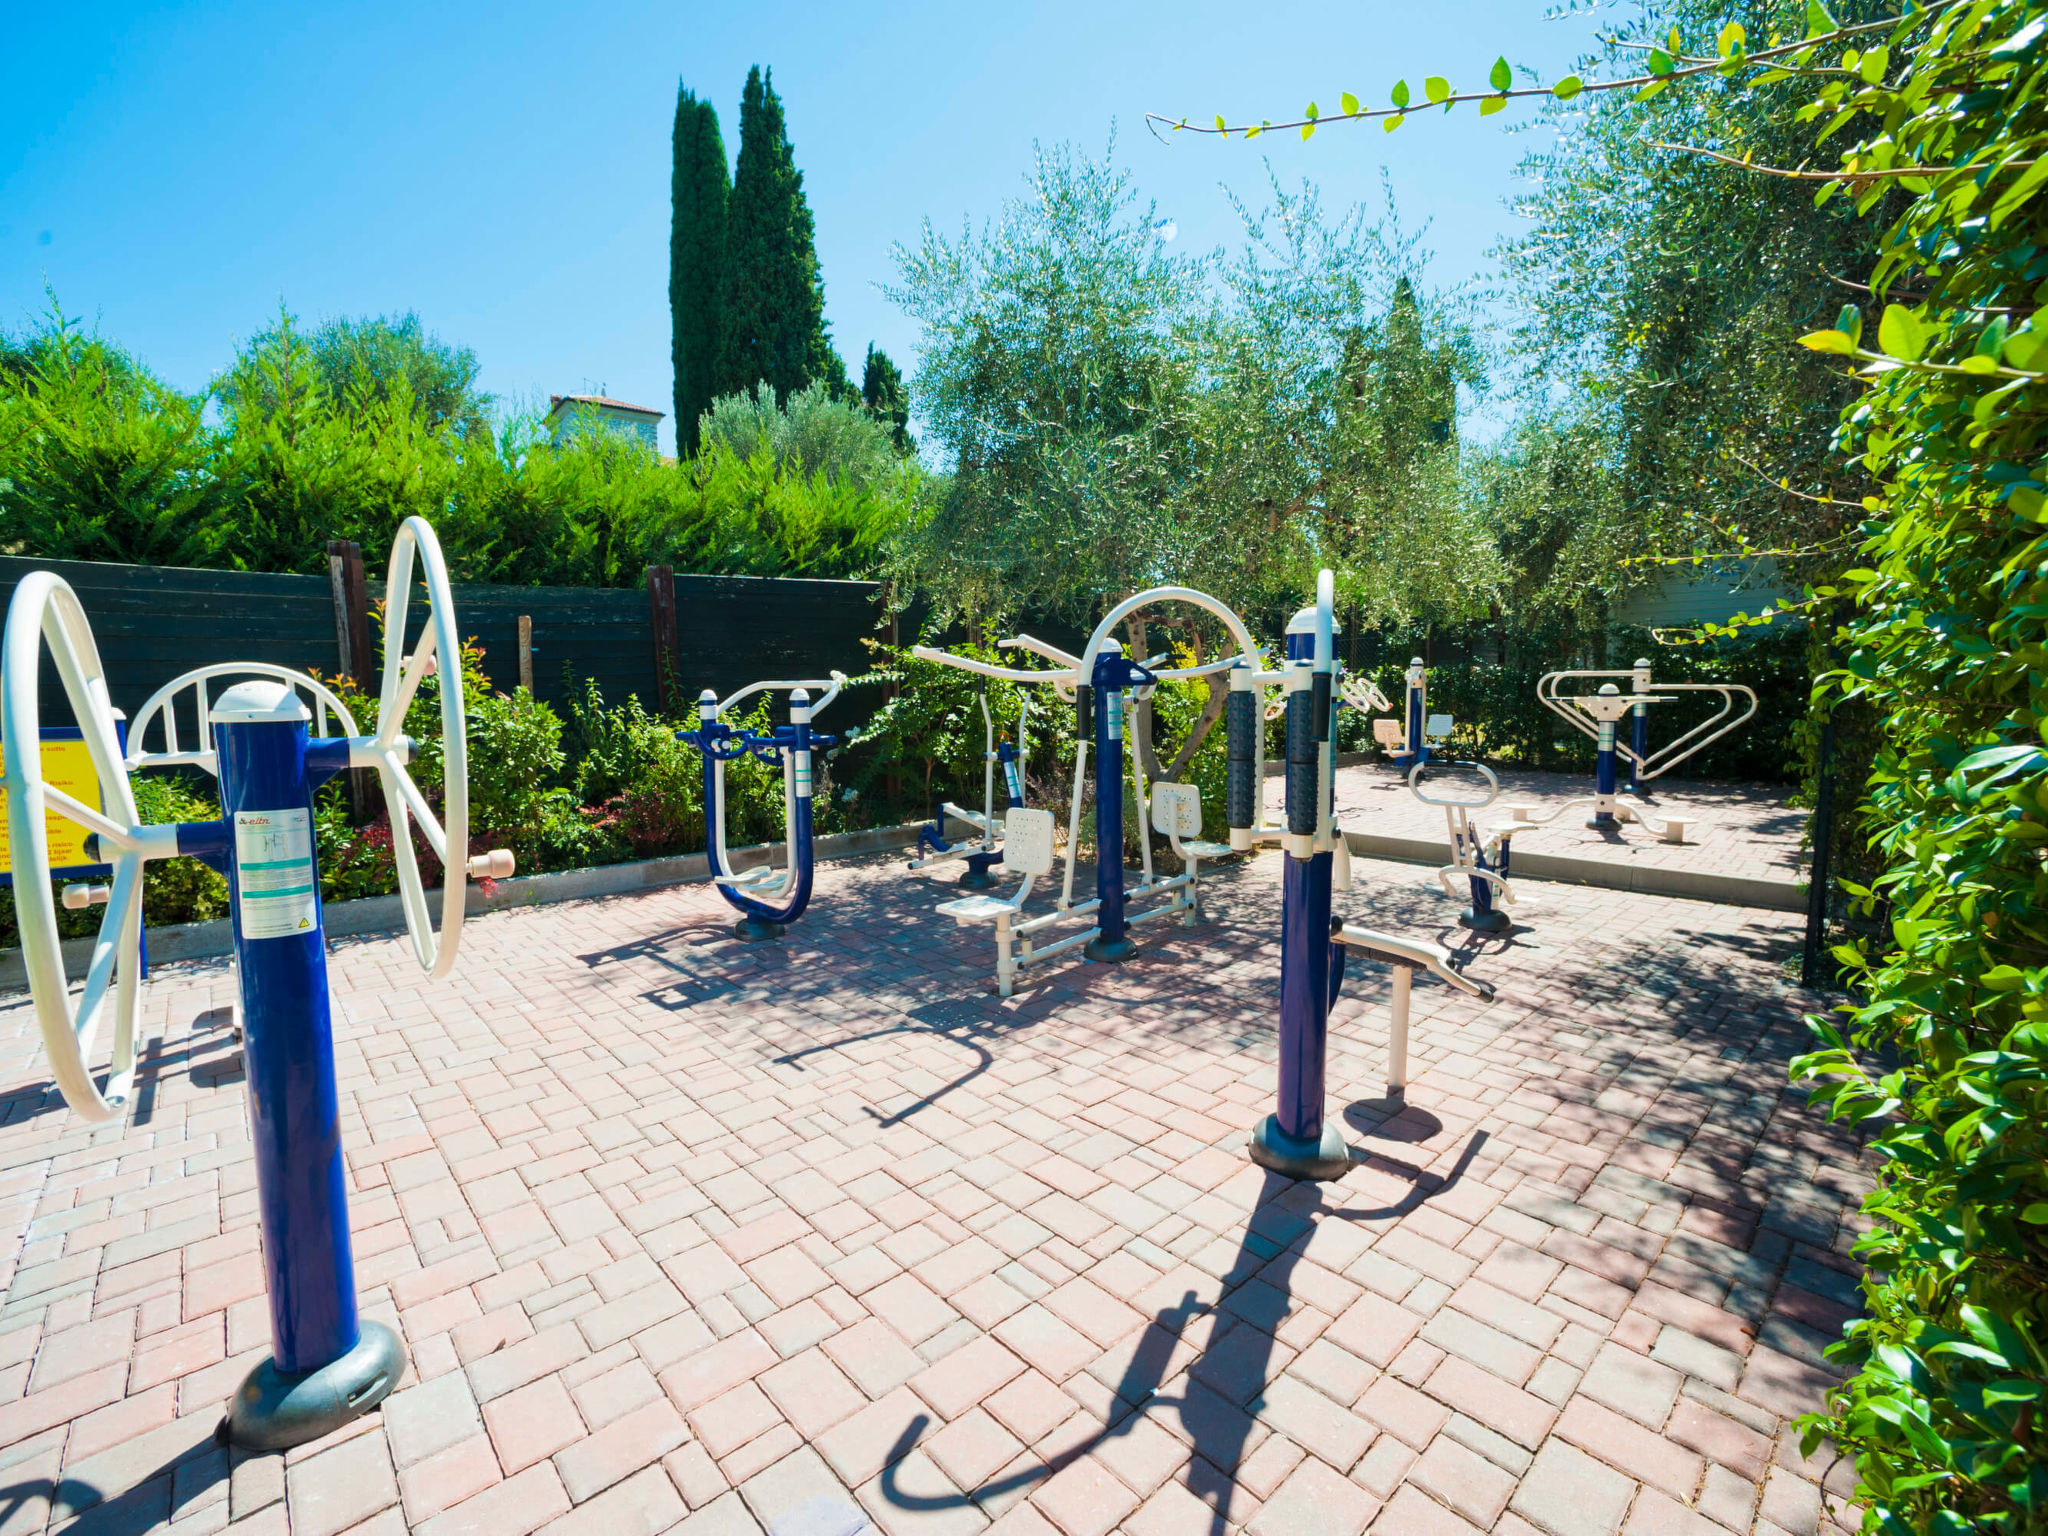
[1507,659,1757,842]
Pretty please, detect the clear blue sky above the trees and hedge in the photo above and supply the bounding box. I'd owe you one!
[0,0,1593,454]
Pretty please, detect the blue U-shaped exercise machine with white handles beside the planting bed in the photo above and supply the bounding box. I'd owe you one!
[676,672,846,942]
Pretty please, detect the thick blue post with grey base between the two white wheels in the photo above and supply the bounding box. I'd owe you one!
[213,684,406,1448]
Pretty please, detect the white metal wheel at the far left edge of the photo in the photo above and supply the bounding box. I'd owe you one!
[0,571,159,1120]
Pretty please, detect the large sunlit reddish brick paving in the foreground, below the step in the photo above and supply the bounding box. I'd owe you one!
[0,856,1866,1536]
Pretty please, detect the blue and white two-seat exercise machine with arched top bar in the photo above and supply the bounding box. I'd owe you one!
[915,586,1278,997]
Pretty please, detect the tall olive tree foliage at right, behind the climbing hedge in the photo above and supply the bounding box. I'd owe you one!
[1501,0,1892,594]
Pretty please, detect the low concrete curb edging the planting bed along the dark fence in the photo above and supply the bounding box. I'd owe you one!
[0,821,971,991]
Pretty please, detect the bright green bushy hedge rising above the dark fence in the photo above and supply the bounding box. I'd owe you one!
[0,313,930,586]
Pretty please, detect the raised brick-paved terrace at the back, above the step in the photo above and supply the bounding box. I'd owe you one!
[1266,764,1806,881]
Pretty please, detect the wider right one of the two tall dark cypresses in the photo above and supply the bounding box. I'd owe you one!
[715,66,846,399]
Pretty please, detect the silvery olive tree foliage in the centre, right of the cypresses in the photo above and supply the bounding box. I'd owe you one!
[889,132,1495,638]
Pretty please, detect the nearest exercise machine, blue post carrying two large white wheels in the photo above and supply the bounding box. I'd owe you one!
[0,518,512,1450]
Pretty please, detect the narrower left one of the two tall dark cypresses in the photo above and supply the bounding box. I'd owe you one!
[668,84,731,459]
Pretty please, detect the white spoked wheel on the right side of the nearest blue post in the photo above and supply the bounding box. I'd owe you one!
[371,518,475,977]
